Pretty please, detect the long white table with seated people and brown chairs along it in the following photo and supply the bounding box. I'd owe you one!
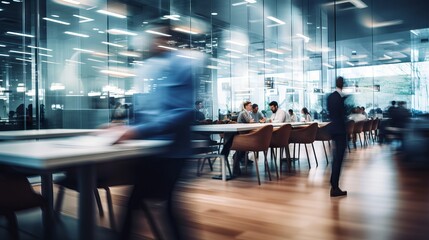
[192,122,328,181]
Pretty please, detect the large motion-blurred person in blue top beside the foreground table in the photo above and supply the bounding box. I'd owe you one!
[112,23,203,239]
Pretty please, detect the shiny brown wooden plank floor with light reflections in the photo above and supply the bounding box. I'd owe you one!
[7,144,429,240]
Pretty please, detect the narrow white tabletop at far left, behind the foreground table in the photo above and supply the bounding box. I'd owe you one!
[0,129,101,140]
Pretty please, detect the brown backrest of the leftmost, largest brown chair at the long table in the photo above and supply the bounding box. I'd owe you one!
[231,125,273,152]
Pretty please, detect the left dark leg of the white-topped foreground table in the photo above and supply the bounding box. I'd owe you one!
[41,173,54,239]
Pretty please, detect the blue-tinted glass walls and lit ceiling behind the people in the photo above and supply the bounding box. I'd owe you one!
[0,0,429,130]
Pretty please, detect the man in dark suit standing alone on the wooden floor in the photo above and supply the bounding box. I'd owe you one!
[328,77,347,197]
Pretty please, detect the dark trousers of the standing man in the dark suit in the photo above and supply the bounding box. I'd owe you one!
[331,134,347,189]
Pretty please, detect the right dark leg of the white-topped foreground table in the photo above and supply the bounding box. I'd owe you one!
[77,165,96,240]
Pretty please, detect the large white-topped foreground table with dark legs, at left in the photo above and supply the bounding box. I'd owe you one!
[0,138,171,240]
